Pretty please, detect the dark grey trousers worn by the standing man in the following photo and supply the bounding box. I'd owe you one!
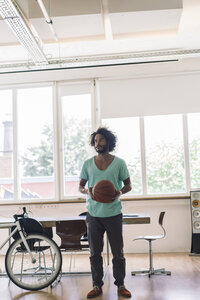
[87,213,125,287]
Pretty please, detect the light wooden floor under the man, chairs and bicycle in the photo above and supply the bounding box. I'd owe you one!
[0,253,200,300]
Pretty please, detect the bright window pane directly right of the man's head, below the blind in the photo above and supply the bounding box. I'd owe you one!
[102,118,142,195]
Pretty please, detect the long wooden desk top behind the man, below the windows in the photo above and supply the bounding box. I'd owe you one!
[0,214,150,228]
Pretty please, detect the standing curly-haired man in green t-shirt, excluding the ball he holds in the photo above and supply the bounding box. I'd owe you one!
[79,127,131,298]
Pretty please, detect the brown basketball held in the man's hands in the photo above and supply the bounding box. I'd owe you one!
[92,180,116,203]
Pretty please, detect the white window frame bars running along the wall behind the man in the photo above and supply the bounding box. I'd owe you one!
[0,79,198,204]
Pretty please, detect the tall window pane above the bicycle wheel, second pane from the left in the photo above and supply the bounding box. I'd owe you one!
[18,87,54,199]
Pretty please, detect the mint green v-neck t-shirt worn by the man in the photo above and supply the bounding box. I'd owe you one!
[80,156,130,217]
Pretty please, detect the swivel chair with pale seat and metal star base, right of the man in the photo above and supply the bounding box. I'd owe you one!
[131,211,171,278]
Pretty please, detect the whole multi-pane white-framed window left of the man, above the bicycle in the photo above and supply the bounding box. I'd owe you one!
[0,82,93,201]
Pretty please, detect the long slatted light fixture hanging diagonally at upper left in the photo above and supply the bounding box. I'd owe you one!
[0,0,48,64]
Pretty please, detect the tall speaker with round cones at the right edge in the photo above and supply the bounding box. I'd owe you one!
[190,190,200,254]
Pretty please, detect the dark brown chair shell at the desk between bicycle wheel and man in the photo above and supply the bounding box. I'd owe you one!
[56,220,87,250]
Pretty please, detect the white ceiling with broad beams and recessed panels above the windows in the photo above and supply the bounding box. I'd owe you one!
[0,0,200,72]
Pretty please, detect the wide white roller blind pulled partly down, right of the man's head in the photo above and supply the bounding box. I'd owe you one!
[99,74,200,118]
